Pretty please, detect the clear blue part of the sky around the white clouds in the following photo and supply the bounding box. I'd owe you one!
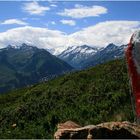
[0,1,140,33]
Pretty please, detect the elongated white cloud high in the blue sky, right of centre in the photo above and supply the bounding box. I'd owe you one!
[57,4,107,18]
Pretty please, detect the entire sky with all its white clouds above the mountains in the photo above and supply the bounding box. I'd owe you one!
[0,1,140,53]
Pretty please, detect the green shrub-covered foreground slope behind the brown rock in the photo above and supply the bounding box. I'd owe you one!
[0,60,133,139]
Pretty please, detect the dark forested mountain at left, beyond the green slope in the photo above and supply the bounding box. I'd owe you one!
[0,44,73,93]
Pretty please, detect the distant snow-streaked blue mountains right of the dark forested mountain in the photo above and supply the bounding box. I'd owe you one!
[58,43,127,69]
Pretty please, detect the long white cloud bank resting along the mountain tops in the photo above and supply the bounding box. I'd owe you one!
[0,21,140,54]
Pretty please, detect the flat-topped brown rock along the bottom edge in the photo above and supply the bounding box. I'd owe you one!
[54,121,140,139]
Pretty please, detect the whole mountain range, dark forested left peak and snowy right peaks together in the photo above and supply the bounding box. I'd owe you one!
[0,43,126,93]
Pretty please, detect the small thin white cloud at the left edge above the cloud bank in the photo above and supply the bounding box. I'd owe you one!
[0,19,28,25]
